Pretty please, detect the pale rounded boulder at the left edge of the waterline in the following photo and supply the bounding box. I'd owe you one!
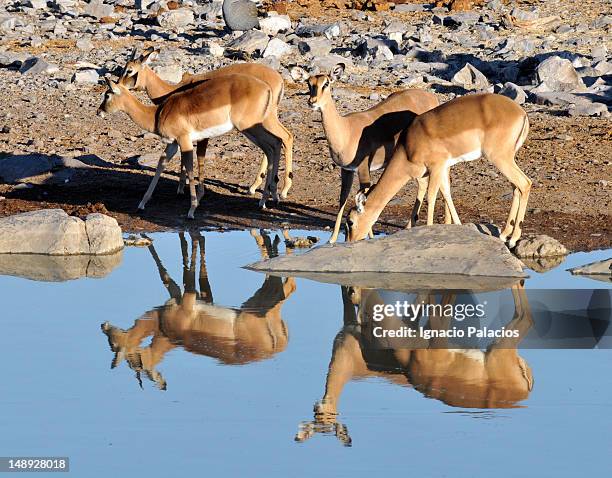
[0,209,123,255]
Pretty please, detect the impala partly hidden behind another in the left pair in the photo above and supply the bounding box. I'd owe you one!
[119,47,293,202]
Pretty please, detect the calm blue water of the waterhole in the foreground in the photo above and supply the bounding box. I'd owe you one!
[0,232,612,477]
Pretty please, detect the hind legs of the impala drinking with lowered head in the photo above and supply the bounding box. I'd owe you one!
[492,158,531,249]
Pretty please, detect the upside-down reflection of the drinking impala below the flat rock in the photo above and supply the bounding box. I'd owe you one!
[295,285,533,445]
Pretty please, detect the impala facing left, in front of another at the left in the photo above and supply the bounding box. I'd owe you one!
[98,75,281,219]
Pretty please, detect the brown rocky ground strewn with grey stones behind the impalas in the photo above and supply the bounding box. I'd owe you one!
[0,0,612,250]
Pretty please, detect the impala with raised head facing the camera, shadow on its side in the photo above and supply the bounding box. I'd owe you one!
[291,63,448,243]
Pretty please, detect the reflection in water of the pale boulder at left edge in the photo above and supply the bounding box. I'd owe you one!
[0,251,123,282]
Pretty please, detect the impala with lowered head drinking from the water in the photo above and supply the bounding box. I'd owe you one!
[348,94,531,248]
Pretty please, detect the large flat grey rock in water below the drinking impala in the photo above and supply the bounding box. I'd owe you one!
[247,224,526,278]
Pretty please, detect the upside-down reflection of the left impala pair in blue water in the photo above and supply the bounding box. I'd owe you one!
[102,232,295,390]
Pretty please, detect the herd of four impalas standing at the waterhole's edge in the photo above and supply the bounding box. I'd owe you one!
[98,48,531,248]
